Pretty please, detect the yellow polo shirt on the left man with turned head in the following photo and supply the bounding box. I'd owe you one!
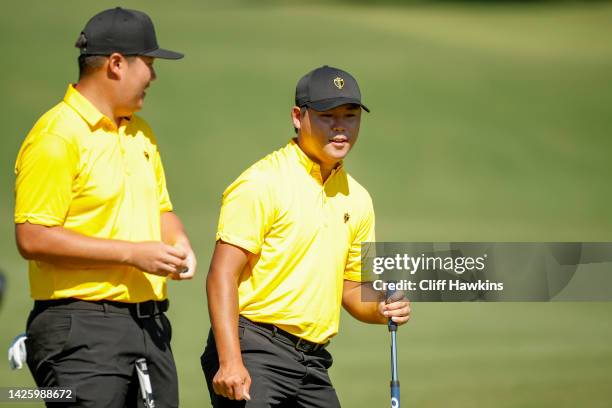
[15,85,172,302]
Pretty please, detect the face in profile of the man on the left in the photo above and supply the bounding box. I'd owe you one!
[119,56,156,116]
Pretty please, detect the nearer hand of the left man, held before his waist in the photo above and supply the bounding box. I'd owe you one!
[127,241,187,276]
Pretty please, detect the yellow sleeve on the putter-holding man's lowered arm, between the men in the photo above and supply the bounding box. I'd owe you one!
[216,172,275,254]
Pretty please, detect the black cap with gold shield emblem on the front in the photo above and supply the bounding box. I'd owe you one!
[295,65,370,112]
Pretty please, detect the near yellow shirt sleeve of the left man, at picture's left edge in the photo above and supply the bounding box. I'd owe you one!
[15,133,79,227]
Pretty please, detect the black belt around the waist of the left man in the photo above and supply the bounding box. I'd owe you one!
[34,298,170,319]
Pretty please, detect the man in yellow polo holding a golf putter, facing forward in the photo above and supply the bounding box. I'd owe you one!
[201,66,410,407]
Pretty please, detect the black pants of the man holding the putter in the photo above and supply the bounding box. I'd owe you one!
[201,318,340,408]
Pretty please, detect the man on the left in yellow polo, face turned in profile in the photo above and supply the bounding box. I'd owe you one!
[15,7,196,407]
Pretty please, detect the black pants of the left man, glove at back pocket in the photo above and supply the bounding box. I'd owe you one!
[26,301,178,408]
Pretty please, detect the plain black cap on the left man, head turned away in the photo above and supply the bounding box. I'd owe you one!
[77,7,184,59]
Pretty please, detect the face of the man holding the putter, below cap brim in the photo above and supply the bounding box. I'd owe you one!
[293,104,361,167]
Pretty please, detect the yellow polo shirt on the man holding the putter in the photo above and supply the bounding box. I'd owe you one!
[217,140,374,343]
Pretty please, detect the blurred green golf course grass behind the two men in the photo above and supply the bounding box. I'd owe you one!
[0,0,612,408]
